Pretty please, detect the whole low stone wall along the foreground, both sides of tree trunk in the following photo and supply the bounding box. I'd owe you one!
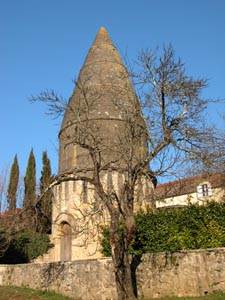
[0,248,225,300]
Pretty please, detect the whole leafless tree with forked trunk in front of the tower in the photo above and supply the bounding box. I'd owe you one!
[31,42,218,299]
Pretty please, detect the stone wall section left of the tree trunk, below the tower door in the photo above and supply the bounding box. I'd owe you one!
[0,258,116,300]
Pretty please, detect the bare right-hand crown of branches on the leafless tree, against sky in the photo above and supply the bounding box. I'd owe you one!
[132,45,219,180]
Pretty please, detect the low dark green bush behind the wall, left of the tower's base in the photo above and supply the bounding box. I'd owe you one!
[0,231,52,264]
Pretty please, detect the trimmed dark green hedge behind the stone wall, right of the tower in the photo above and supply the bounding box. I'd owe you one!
[102,202,225,256]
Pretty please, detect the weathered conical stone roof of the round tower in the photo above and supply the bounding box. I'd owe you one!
[59,27,147,173]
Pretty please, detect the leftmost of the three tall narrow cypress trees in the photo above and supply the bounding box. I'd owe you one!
[7,155,19,213]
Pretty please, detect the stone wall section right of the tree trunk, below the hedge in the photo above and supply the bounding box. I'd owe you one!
[137,248,225,298]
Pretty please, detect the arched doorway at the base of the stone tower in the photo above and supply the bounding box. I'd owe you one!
[60,222,72,261]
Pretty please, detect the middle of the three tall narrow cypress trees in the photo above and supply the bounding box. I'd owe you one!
[23,149,36,209]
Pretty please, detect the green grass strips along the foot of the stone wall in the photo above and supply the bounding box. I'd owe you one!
[0,286,225,300]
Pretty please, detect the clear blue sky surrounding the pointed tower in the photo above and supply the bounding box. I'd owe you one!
[0,0,225,184]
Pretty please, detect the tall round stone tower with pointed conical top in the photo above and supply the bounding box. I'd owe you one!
[52,28,155,260]
